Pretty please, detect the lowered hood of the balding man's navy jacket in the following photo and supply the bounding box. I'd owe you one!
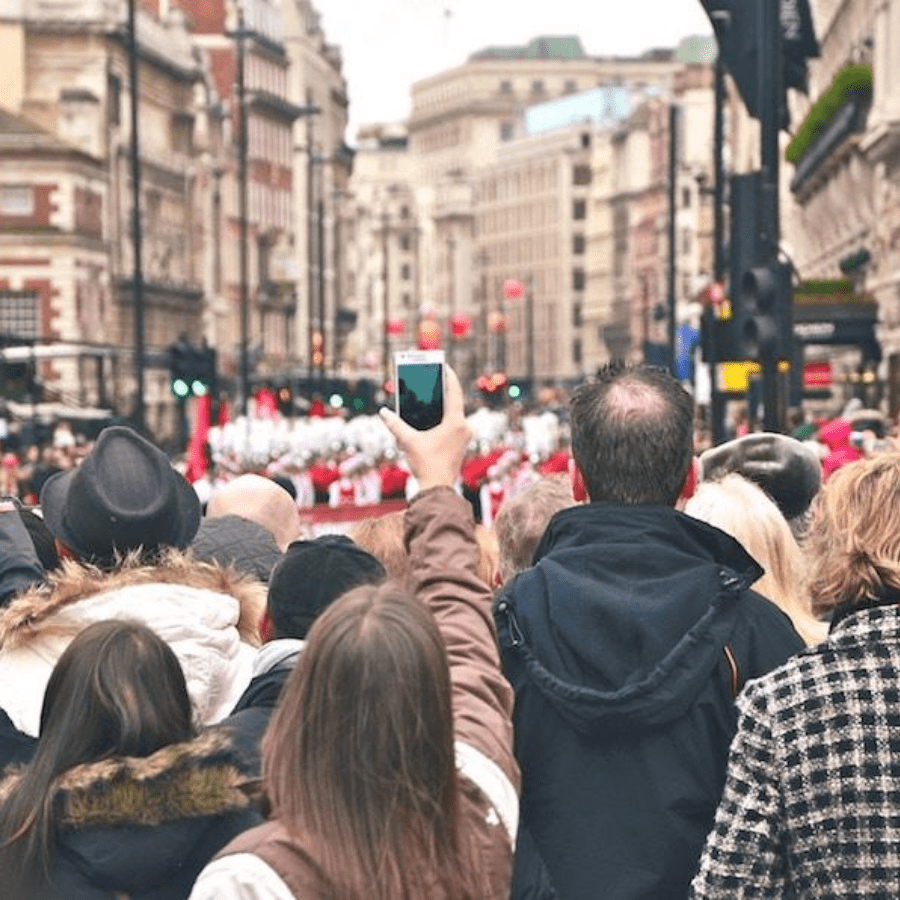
[496,503,763,734]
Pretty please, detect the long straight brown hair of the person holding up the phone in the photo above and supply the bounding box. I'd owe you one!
[263,582,474,900]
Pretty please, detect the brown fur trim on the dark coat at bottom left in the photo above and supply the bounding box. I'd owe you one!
[0,733,253,829]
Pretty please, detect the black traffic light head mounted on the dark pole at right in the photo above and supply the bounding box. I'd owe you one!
[735,262,793,361]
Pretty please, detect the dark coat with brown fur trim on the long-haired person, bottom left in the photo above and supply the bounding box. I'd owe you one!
[0,737,262,900]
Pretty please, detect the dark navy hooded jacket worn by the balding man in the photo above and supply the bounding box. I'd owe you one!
[495,503,803,900]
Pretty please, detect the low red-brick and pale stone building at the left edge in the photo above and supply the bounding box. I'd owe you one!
[0,112,110,408]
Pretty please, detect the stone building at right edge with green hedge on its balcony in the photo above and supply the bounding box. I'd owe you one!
[782,0,900,416]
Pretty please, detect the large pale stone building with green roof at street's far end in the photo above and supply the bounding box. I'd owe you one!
[344,36,711,388]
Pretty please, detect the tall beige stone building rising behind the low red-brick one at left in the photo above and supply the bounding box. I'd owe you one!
[0,0,206,432]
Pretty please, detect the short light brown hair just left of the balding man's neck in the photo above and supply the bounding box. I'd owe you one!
[494,474,575,581]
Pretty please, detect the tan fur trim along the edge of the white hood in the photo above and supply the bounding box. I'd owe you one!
[0,550,266,647]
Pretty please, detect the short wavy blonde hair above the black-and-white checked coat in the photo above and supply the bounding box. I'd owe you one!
[807,453,900,612]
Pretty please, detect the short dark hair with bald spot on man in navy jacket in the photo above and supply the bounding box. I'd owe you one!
[570,362,694,506]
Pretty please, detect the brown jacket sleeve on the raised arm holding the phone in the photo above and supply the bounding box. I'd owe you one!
[406,488,519,790]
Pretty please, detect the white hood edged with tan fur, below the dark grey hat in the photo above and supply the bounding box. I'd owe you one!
[0,551,265,736]
